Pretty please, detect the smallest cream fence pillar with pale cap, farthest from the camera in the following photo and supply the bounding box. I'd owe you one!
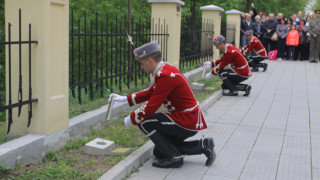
[226,9,241,48]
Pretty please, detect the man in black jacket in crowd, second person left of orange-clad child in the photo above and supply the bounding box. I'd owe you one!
[262,13,278,54]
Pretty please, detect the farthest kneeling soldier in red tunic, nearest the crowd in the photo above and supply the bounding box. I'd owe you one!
[241,30,268,72]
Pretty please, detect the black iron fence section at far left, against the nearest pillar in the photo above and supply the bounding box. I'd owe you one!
[0,9,38,134]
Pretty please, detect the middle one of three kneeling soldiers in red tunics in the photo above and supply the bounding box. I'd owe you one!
[204,35,252,96]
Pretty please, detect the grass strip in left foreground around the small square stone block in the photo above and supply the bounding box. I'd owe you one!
[0,118,148,179]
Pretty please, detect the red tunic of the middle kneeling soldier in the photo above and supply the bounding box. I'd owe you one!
[212,43,252,77]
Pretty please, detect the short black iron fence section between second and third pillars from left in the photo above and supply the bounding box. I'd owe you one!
[180,19,214,69]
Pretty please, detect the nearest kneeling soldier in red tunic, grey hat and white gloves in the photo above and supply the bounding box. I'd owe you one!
[112,41,216,168]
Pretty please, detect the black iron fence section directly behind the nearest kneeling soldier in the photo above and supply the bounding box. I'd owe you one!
[69,11,168,104]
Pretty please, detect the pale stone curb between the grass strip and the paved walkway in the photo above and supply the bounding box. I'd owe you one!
[99,90,222,180]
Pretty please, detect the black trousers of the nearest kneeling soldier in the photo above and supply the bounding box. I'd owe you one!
[138,113,197,157]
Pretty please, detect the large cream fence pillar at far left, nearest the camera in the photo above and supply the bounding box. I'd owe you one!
[5,0,69,139]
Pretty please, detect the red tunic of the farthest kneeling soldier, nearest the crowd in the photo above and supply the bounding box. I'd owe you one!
[241,36,267,57]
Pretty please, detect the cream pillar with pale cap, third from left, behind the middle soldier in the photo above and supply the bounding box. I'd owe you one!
[200,5,224,59]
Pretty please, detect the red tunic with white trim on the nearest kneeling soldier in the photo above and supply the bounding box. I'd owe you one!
[127,62,207,130]
